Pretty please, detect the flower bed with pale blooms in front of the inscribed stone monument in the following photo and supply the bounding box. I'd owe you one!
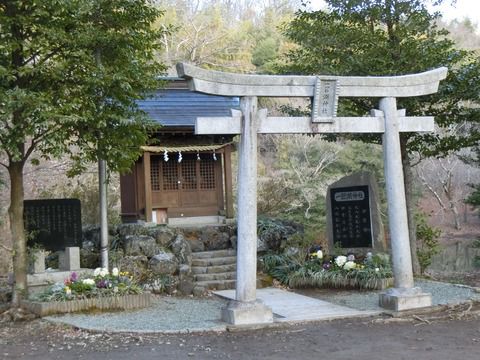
[262,250,393,290]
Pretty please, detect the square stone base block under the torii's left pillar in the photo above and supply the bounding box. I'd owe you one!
[222,300,273,325]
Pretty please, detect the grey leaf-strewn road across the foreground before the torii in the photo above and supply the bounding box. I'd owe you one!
[0,313,480,360]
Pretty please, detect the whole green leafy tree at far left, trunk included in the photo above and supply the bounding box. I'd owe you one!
[0,0,163,306]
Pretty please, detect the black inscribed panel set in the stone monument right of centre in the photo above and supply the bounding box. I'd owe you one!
[330,186,372,248]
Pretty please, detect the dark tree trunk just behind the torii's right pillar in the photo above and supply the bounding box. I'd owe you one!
[400,134,420,275]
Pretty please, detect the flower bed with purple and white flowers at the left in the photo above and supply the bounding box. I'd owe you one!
[22,268,150,316]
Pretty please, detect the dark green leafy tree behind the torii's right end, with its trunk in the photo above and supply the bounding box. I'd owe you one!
[278,0,480,273]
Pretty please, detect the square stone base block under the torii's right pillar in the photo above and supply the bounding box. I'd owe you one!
[379,288,432,311]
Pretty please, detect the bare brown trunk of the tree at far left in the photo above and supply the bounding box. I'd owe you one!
[8,161,27,307]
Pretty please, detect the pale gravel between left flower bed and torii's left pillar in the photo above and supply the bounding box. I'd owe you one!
[45,296,230,333]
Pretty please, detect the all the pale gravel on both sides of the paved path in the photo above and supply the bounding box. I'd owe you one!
[45,280,480,333]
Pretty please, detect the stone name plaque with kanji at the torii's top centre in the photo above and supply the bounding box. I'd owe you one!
[312,78,338,122]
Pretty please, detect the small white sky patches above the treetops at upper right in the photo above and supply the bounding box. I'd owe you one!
[311,0,480,32]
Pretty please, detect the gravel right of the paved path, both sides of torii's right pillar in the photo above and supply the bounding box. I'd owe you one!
[296,280,480,310]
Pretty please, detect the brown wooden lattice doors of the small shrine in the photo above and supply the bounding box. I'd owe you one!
[151,153,223,217]
